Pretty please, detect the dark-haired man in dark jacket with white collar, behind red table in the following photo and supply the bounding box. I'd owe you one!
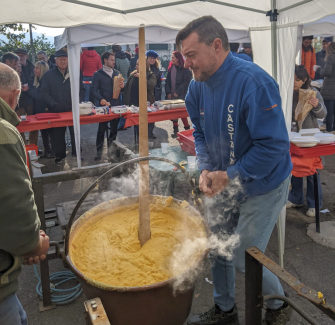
[91,52,124,161]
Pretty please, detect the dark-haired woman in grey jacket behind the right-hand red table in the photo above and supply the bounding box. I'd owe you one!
[286,65,327,217]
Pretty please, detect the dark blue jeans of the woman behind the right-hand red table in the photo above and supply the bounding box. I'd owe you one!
[288,175,322,209]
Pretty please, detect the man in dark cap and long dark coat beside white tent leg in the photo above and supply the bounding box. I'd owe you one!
[41,50,85,163]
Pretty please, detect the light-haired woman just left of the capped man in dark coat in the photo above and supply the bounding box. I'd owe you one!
[26,61,54,158]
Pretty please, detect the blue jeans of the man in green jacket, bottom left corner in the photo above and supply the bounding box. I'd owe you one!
[0,293,28,325]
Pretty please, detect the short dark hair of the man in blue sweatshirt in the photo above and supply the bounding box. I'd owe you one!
[176,16,229,51]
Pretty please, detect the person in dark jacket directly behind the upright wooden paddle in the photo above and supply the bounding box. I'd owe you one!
[123,60,157,139]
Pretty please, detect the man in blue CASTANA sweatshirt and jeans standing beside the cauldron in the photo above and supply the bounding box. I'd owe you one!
[176,16,292,325]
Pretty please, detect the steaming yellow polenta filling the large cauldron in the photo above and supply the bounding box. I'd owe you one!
[70,198,206,287]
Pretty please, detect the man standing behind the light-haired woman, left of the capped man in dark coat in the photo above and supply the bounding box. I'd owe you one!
[15,48,34,115]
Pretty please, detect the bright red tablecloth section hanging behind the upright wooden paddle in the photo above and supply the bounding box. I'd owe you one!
[125,108,188,128]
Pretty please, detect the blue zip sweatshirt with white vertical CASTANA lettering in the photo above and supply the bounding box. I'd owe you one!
[186,53,292,196]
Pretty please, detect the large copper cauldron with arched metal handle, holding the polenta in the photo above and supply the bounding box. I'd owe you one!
[65,157,208,325]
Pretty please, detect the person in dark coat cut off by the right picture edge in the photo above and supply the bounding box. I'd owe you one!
[315,42,335,132]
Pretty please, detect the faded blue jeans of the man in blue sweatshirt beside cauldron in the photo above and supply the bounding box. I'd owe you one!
[206,177,290,311]
